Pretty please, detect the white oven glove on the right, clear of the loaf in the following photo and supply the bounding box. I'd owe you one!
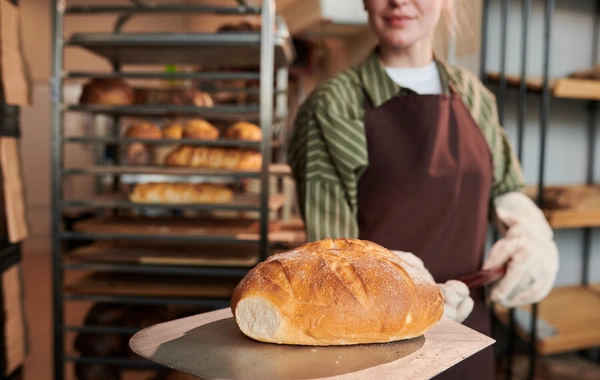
[483,192,558,307]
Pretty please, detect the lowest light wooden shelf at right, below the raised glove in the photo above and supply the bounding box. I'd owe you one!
[495,286,600,355]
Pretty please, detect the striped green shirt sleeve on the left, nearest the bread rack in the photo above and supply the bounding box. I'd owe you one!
[289,73,367,241]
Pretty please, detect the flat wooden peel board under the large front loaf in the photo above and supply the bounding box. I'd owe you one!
[130,309,494,380]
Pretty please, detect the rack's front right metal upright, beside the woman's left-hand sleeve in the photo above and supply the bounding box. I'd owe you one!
[260,0,275,260]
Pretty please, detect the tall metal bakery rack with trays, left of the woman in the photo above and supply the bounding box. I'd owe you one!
[52,0,295,379]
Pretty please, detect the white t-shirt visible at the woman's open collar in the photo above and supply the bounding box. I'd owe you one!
[385,61,442,95]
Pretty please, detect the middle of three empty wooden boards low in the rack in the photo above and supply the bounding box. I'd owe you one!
[69,242,259,267]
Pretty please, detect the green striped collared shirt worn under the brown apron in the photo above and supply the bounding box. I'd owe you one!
[289,52,524,241]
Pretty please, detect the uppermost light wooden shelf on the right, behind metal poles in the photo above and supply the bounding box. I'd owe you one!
[488,73,600,100]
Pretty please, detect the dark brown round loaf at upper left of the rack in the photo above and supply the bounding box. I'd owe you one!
[79,78,135,106]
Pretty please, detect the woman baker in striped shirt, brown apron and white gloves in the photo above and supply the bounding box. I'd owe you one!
[290,0,558,379]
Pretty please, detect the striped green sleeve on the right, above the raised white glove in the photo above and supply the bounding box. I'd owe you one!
[453,68,525,200]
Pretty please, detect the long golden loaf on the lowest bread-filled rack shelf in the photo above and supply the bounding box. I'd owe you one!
[129,183,233,204]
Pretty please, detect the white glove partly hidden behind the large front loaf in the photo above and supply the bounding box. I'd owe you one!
[392,251,474,323]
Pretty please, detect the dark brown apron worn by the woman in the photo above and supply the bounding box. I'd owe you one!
[358,90,494,380]
